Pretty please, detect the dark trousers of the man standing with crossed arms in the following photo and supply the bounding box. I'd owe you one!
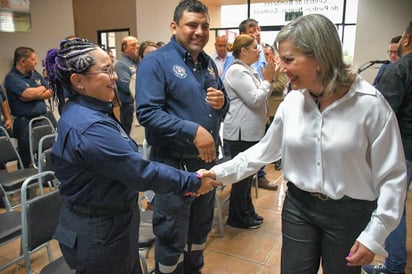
[13,117,47,168]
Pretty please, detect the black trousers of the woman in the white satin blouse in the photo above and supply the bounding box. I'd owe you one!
[281,182,376,274]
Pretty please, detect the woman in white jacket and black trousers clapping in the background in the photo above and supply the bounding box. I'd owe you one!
[223,34,276,229]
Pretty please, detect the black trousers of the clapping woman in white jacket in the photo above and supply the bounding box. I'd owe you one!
[226,140,256,227]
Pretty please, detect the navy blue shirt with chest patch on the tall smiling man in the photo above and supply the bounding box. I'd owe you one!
[136,37,229,155]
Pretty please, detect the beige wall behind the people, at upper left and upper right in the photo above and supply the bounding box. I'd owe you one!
[0,0,412,86]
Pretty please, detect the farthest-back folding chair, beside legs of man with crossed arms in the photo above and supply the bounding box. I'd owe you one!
[29,116,56,169]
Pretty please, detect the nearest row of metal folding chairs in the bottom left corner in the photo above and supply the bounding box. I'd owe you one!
[0,171,75,274]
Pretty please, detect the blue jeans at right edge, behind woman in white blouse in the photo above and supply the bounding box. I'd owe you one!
[385,160,412,273]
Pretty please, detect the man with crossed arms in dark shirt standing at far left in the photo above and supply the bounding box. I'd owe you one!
[4,47,53,167]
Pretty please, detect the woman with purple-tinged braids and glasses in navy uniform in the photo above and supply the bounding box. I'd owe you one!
[47,39,217,274]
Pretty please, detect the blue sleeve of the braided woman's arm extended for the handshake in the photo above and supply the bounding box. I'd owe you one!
[77,123,200,194]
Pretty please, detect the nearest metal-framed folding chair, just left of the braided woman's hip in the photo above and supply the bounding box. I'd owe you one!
[21,171,75,274]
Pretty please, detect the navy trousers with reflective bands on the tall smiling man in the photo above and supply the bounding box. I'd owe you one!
[151,152,215,274]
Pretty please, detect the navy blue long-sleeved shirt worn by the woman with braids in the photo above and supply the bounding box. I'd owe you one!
[52,95,200,208]
